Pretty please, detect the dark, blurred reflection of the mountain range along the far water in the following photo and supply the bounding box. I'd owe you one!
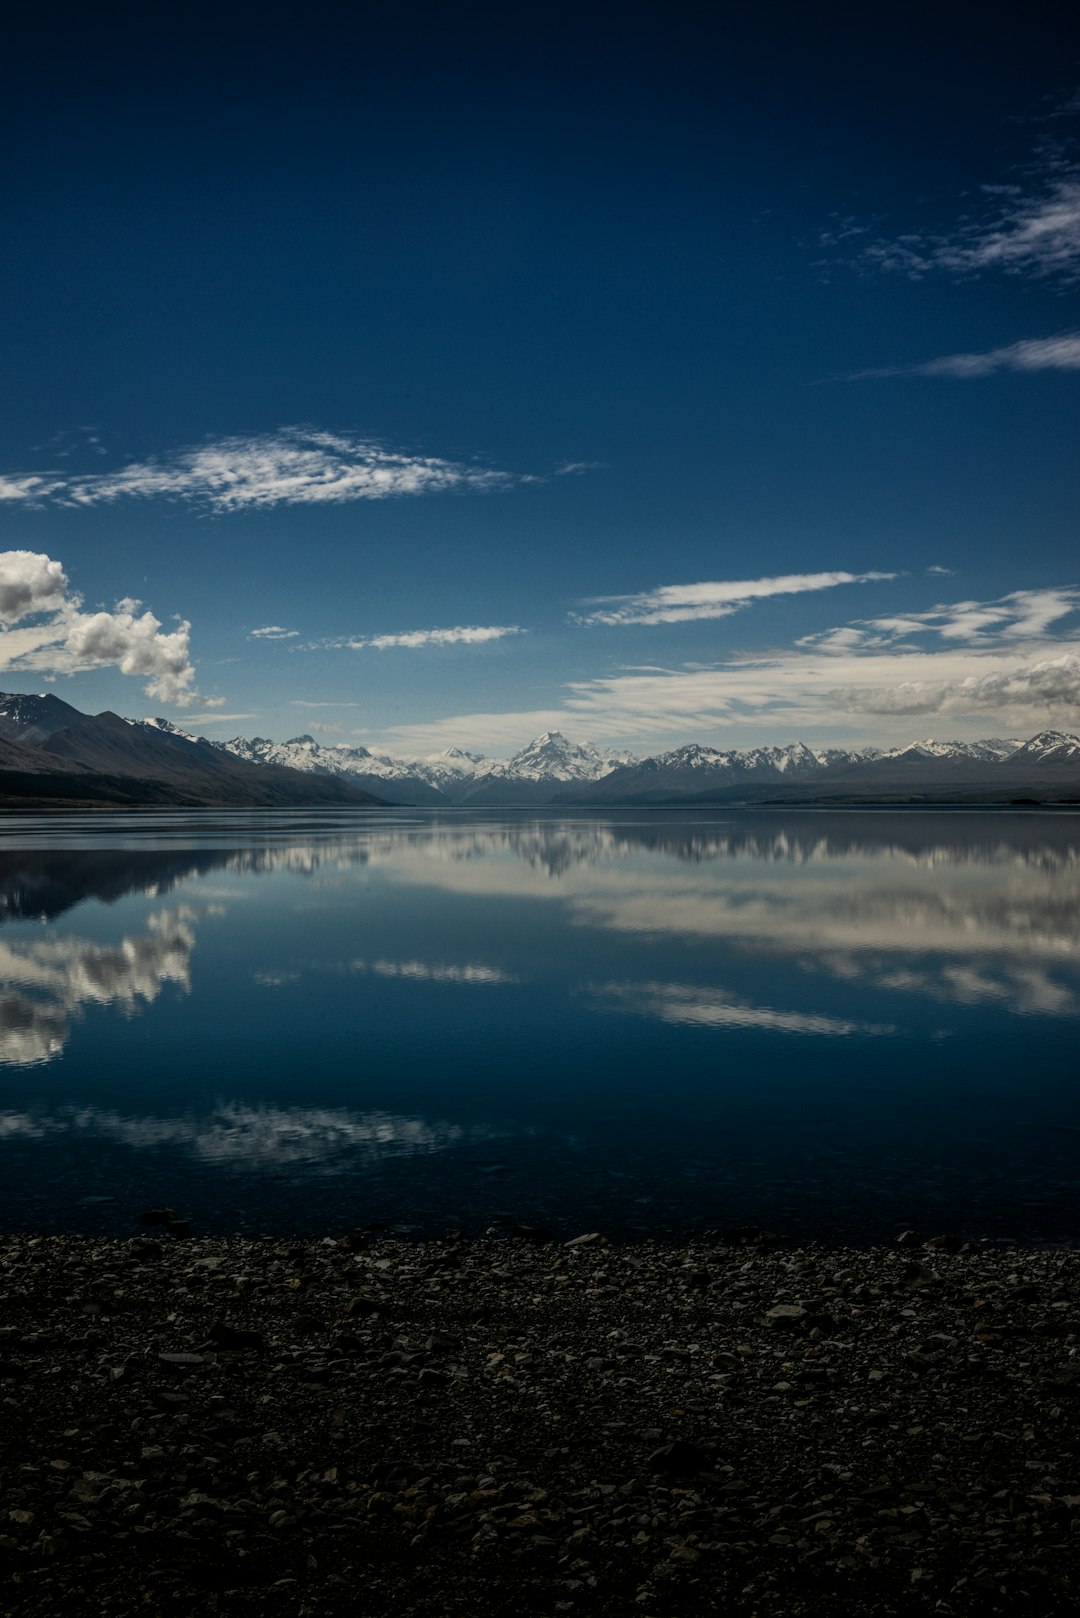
[0,811,1080,922]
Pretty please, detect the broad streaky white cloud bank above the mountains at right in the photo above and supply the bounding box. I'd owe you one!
[375,587,1080,752]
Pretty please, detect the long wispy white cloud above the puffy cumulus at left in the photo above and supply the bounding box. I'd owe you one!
[0,427,536,511]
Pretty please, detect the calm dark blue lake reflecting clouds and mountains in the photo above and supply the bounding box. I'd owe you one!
[0,811,1080,1243]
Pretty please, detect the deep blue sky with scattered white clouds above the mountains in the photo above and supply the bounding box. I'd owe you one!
[0,5,1080,754]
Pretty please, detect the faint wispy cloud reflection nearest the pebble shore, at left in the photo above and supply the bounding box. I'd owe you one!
[0,1102,494,1173]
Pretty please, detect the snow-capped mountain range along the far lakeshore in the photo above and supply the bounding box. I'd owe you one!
[0,694,1080,807]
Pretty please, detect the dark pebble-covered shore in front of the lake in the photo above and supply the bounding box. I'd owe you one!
[0,1233,1080,1618]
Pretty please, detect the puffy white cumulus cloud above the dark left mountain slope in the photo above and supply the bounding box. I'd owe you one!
[0,550,206,707]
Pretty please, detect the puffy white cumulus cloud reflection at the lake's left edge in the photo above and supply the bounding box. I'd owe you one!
[0,904,220,1066]
